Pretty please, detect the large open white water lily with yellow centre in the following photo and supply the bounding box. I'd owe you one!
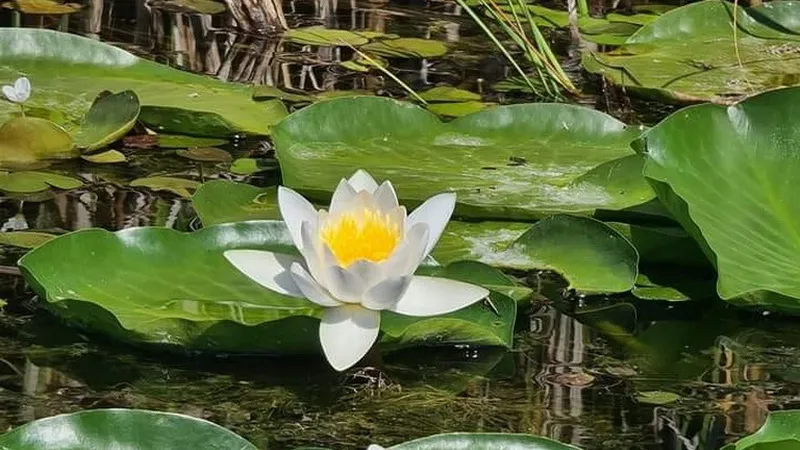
[225,170,489,371]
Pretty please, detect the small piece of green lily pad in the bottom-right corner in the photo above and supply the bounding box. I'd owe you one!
[722,410,800,450]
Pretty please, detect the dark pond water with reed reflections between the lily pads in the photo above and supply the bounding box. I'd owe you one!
[0,0,800,450]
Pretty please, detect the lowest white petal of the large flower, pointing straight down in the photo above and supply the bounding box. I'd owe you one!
[319,305,381,372]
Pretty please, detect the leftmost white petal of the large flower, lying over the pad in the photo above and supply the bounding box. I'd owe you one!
[223,250,305,297]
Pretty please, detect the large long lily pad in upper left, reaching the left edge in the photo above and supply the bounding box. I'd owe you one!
[0,28,286,135]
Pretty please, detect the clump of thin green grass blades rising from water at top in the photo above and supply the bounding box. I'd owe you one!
[456,0,578,99]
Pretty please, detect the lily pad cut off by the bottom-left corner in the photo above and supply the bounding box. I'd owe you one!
[0,409,256,450]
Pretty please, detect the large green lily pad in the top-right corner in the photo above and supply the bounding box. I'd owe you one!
[583,0,800,103]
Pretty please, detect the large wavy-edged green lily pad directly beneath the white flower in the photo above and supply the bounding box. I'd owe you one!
[19,221,516,353]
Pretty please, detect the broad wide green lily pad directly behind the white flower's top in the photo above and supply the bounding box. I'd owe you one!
[273,97,653,220]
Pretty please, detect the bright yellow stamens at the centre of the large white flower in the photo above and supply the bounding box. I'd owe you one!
[320,208,400,267]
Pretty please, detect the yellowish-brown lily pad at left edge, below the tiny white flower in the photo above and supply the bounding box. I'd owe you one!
[0,117,79,164]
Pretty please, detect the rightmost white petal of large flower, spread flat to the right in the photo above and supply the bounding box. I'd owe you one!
[390,276,489,317]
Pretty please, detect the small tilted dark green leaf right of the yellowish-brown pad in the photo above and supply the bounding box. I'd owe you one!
[74,91,140,152]
